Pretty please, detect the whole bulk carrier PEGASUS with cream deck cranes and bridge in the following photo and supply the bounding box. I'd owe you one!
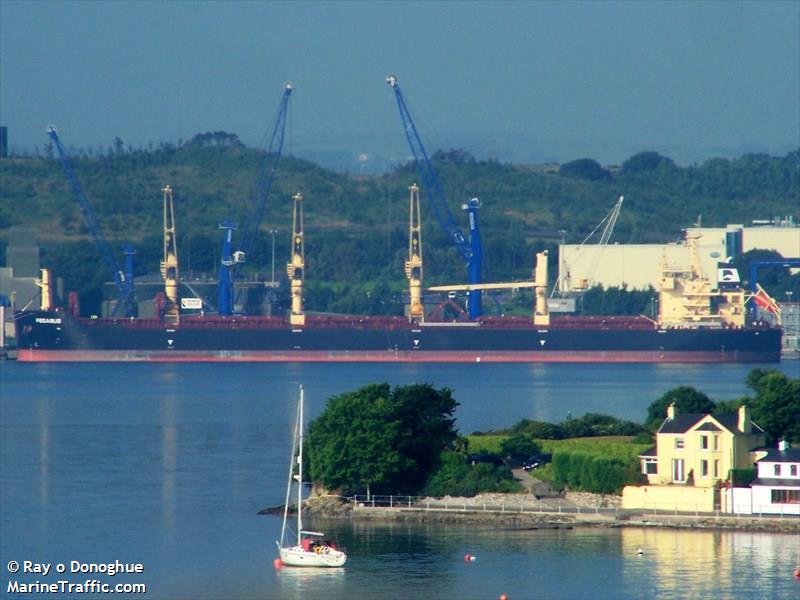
[15,186,781,363]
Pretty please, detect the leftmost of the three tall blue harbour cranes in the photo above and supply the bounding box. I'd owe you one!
[47,127,137,317]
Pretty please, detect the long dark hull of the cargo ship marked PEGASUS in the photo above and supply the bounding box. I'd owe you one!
[16,311,781,362]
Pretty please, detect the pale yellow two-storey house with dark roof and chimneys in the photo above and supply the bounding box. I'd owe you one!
[622,404,765,512]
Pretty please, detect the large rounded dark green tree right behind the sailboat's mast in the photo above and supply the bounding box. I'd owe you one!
[308,383,458,493]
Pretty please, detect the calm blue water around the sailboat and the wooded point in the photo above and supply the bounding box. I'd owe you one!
[0,363,800,600]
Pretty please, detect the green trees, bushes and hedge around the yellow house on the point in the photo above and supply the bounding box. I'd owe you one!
[306,369,800,496]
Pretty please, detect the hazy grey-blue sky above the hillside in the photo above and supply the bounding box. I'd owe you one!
[0,0,800,171]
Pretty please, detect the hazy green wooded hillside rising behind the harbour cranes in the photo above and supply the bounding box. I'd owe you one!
[0,136,800,307]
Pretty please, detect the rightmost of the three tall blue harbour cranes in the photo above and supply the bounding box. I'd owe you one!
[386,75,483,319]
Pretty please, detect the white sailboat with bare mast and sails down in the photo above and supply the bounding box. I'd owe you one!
[275,386,347,567]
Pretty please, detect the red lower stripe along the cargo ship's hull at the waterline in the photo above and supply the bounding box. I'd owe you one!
[18,349,774,363]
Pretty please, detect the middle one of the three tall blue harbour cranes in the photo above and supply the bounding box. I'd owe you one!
[218,83,294,316]
